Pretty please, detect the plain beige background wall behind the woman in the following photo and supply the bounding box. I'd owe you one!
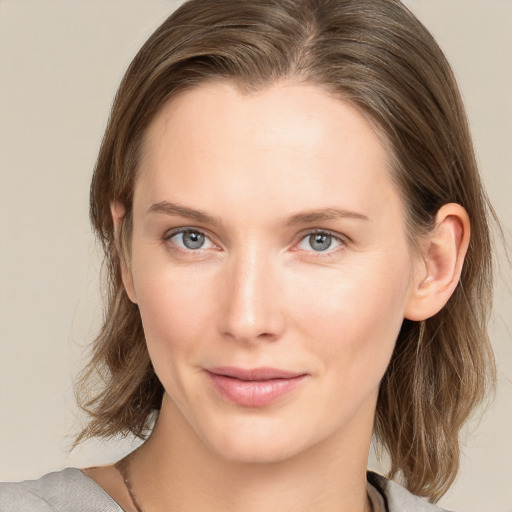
[0,0,512,512]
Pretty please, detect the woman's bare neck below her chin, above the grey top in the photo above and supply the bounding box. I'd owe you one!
[129,399,371,512]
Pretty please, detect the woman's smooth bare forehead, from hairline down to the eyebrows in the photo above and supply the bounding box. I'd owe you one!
[136,81,404,222]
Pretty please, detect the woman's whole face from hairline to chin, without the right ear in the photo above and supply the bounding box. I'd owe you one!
[125,82,415,462]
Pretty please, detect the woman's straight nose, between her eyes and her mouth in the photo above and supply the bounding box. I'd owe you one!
[220,249,285,343]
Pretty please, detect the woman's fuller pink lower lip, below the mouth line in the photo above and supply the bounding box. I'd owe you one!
[207,372,306,407]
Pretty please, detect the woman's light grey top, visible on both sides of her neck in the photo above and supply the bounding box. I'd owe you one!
[0,468,447,512]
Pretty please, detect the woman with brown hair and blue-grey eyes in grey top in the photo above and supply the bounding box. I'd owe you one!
[1,0,500,511]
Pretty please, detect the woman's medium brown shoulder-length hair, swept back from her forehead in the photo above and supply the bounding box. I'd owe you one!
[77,0,494,500]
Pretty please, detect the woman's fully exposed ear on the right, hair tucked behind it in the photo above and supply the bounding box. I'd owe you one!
[405,203,470,321]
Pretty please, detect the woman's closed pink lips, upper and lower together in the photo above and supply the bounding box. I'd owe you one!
[206,366,307,407]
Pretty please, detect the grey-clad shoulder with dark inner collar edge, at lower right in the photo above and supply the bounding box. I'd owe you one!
[367,471,449,512]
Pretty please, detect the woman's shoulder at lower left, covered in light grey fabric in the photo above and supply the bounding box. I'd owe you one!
[0,468,122,512]
